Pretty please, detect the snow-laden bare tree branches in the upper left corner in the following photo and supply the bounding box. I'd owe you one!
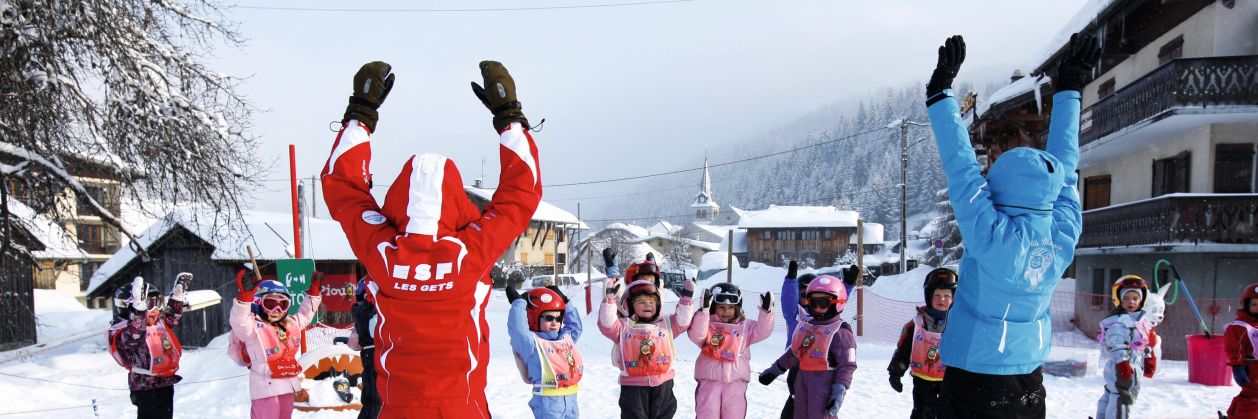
[0,0,263,256]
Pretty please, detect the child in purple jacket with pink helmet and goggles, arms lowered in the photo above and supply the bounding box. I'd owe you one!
[760,276,857,419]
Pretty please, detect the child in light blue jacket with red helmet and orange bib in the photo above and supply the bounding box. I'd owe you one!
[507,284,585,419]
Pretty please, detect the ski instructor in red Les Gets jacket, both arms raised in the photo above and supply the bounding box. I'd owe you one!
[322,62,542,418]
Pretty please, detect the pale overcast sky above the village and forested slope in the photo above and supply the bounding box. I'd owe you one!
[210,0,1084,216]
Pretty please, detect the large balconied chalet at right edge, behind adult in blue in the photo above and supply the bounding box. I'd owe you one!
[967,0,1258,359]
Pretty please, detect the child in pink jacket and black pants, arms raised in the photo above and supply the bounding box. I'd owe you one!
[599,260,694,419]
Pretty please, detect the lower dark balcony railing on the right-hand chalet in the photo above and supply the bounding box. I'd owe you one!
[1078,194,1258,248]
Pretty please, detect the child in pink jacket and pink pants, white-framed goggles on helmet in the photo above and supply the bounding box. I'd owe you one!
[688,283,774,419]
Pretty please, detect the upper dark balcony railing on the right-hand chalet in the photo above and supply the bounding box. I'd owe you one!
[1079,55,1258,145]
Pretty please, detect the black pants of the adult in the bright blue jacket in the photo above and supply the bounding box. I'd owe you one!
[938,366,1045,419]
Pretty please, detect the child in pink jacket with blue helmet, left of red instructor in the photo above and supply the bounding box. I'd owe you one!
[228,273,321,419]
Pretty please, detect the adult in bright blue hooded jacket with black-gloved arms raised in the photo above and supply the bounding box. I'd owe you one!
[926,35,1099,418]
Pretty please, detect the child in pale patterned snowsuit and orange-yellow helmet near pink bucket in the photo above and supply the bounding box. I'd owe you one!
[1096,276,1152,419]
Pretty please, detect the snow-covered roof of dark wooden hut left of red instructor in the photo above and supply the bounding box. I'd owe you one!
[87,209,357,294]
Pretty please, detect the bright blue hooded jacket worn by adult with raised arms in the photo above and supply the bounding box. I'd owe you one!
[927,89,1083,375]
